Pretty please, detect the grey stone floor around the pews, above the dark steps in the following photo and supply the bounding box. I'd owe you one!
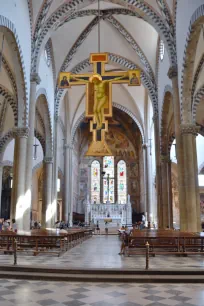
[0,236,204,270]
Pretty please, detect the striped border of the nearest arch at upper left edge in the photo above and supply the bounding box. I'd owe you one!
[0,15,29,126]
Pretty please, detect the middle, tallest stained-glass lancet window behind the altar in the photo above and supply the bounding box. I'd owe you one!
[103,156,115,203]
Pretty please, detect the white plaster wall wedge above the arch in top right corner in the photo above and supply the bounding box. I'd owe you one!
[176,0,204,98]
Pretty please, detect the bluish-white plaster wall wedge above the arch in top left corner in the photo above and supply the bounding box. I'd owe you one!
[0,0,31,93]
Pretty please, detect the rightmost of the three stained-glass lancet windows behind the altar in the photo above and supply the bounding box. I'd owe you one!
[117,160,127,204]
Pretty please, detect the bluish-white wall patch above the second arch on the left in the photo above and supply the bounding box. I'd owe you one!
[37,52,55,126]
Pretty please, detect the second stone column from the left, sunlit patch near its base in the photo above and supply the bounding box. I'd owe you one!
[42,157,55,228]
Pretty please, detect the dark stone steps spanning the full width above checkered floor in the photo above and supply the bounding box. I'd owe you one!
[0,266,204,283]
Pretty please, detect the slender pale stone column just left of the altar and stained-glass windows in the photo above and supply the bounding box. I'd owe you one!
[64,144,73,226]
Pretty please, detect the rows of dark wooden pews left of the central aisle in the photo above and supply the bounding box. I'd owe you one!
[0,228,92,256]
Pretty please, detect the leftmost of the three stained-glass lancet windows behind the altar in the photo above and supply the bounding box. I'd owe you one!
[91,160,100,204]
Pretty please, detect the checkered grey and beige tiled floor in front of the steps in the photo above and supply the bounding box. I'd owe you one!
[0,280,204,306]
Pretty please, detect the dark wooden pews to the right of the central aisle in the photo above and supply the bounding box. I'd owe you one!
[125,230,204,256]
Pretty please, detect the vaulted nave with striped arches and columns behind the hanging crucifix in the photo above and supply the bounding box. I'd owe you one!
[0,0,204,232]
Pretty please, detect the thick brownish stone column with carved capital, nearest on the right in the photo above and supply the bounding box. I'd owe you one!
[181,124,201,232]
